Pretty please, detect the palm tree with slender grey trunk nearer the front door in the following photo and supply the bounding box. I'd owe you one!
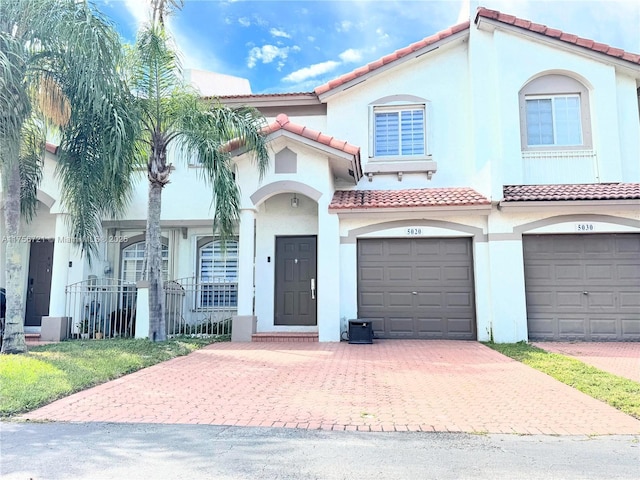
[128,0,269,341]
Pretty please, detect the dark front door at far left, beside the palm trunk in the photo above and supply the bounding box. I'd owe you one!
[24,241,53,327]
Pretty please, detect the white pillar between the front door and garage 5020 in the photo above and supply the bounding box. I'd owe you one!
[316,205,341,342]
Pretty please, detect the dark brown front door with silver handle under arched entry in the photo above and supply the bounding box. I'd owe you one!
[274,236,317,326]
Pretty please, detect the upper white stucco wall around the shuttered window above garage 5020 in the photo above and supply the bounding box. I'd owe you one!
[327,42,474,188]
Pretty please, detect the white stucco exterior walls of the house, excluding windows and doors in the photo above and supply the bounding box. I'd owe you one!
[6,15,640,342]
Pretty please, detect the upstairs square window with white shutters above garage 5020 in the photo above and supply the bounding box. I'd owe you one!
[374,105,426,157]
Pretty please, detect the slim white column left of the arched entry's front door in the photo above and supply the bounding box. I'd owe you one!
[238,208,256,316]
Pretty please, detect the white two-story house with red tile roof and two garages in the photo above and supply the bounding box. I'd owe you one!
[0,8,640,342]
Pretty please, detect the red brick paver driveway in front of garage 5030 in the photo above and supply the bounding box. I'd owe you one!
[534,342,640,383]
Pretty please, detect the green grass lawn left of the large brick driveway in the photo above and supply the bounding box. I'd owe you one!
[0,336,229,417]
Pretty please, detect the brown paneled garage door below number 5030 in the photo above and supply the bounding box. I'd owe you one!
[523,234,640,341]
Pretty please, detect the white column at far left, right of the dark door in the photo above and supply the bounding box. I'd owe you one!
[49,213,71,317]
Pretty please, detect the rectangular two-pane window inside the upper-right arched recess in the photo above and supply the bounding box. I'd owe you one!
[526,95,582,146]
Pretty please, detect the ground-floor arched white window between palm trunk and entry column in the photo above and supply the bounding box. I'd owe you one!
[195,236,240,311]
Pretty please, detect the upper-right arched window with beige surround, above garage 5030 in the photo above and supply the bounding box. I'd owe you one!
[520,74,592,150]
